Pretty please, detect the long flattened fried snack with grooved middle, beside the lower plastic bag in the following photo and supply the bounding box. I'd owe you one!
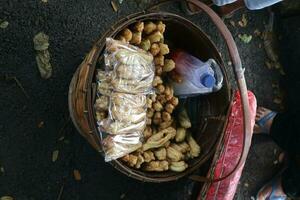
[142,127,176,151]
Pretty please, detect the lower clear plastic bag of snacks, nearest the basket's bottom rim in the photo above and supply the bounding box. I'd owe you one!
[100,92,146,161]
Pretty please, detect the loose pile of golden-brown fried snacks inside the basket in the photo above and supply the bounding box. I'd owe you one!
[95,21,200,172]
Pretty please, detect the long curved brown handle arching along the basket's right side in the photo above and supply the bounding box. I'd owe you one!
[148,0,252,182]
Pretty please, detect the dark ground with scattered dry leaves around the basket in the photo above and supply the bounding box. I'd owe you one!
[0,0,280,200]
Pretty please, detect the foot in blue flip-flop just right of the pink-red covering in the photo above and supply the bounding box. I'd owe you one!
[253,107,277,134]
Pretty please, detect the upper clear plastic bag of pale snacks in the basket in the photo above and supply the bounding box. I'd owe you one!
[104,38,154,94]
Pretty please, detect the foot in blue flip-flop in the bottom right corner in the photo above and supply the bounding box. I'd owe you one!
[256,177,287,200]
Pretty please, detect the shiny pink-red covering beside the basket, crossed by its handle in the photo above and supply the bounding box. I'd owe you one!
[198,91,257,200]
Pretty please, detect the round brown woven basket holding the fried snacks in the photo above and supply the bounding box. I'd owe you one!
[69,0,250,182]
